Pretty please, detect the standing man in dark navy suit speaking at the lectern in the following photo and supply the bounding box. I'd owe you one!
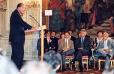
[9,3,32,69]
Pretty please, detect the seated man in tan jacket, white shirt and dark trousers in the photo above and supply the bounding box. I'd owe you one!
[59,32,74,71]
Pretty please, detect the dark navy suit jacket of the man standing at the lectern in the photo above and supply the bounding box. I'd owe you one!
[9,10,32,42]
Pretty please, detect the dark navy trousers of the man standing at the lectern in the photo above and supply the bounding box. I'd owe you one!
[11,42,24,69]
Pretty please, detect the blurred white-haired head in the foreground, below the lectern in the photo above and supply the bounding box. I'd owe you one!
[20,61,56,74]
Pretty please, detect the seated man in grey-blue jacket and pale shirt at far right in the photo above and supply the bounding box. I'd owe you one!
[96,32,114,70]
